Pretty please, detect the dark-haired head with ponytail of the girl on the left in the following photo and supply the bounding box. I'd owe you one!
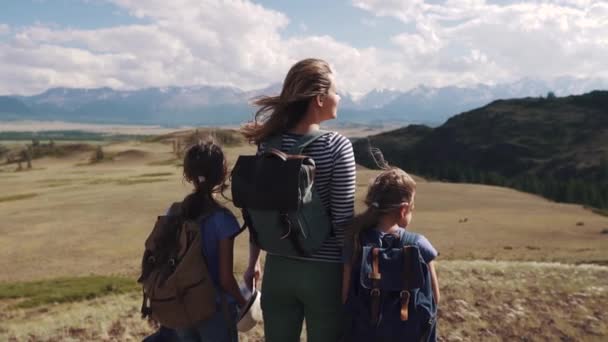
[183,141,228,217]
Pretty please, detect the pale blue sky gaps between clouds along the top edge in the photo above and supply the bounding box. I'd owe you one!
[0,0,413,48]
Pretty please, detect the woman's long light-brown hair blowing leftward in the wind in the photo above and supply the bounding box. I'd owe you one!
[241,58,332,144]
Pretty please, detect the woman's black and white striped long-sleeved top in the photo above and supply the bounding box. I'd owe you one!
[260,132,355,262]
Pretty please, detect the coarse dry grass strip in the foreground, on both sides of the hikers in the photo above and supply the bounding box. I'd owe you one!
[0,261,608,341]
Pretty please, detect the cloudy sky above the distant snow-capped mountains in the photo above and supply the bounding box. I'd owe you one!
[0,0,608,97]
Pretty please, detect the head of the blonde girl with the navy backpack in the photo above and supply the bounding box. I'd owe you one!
[365,167,416,227]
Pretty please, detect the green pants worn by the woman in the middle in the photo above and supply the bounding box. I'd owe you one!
[261,255,342,342]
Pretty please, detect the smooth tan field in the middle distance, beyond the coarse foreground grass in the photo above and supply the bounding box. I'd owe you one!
[0,138,608,281]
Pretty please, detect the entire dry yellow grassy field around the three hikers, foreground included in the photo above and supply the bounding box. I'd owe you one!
[0,130,608,341]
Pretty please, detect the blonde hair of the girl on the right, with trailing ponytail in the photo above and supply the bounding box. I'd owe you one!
[347,167,416,257]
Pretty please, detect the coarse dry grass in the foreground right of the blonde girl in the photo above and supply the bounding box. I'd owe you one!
[439,261,608,341]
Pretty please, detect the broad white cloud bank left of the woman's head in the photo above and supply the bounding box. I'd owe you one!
[0,0,291,93]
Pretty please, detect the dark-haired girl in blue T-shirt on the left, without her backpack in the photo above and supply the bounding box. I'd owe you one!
[177,141,246,342]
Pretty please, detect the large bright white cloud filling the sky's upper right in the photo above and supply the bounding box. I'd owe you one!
[353,0,608,84]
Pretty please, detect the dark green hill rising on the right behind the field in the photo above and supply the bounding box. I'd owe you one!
[354,91,608,208]
